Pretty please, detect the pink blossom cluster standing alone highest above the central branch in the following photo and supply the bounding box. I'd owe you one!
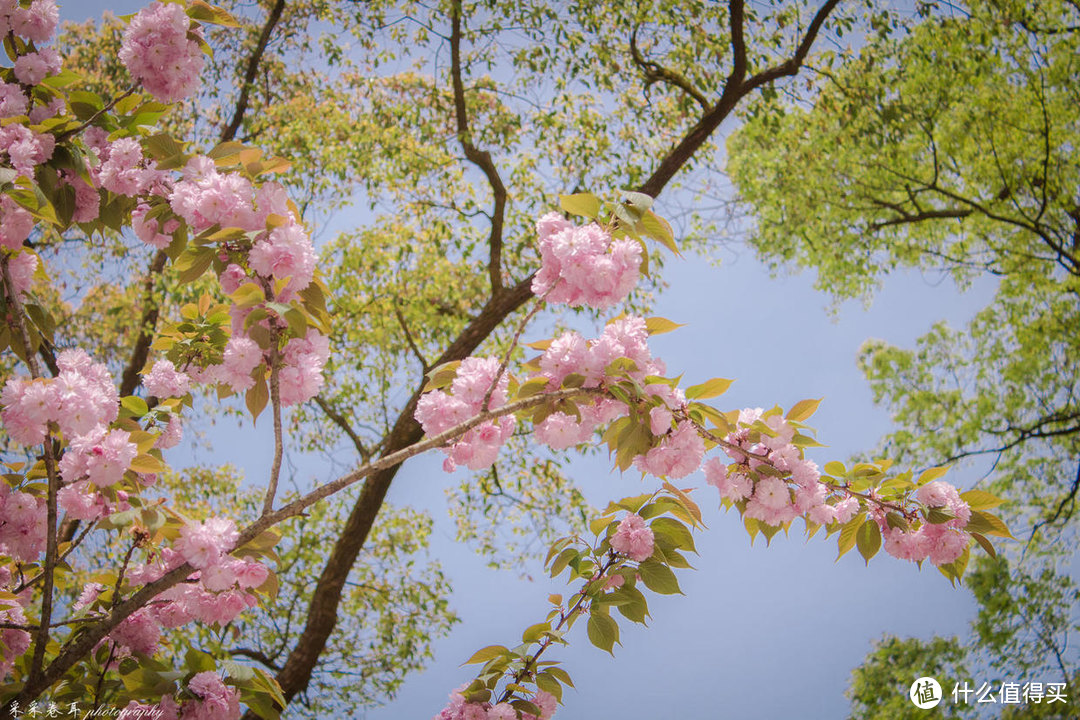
[532,213,642,310]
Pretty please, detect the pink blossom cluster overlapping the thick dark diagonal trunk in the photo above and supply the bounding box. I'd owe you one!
[416,357,516,473]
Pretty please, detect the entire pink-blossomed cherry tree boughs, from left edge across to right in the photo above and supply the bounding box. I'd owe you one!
[0,0,1009,720]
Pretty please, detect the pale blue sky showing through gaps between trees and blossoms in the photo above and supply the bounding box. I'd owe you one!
[62,0,1002,720]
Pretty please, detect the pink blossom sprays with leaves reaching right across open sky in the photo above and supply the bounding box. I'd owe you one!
[416,193,1011,720]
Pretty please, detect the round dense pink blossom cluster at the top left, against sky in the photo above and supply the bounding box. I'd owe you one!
[120,2,205,103]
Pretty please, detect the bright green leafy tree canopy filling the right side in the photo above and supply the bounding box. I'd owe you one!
[729,0,1080,718]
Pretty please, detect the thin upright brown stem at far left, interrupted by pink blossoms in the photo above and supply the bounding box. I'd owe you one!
[0,255,59,684]
